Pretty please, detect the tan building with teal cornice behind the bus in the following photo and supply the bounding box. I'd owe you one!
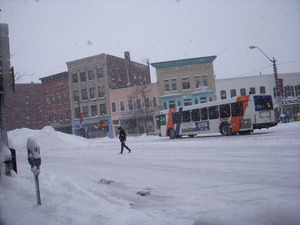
[151,56,216,109]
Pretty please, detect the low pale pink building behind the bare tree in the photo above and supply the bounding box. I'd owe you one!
[109,84,161,137]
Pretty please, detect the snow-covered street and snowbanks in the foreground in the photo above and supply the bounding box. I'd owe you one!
[0,122,300,225]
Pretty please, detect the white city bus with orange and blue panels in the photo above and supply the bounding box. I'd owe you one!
[159,95,277,139]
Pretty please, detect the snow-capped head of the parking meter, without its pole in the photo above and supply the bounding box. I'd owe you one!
[27,137,41,174]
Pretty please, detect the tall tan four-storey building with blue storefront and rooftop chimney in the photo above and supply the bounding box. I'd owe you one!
[67,52,151,138]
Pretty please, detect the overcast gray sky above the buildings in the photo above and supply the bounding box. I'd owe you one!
[0,0,300,83]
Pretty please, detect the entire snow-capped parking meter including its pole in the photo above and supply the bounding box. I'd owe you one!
[27,137,41,205]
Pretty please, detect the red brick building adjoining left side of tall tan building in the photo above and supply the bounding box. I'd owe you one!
[40,72,72,133]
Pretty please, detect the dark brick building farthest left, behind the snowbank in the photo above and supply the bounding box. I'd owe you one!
[6,83,46,131]
